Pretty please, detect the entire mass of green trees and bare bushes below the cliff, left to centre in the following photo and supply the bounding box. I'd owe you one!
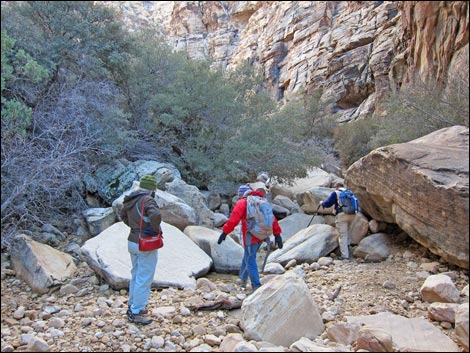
[1,1,330,241]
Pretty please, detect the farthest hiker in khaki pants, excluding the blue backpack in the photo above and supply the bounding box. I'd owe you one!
[319,182,356,260]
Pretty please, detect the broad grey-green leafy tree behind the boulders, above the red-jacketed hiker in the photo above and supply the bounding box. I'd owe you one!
[128,48,332,187]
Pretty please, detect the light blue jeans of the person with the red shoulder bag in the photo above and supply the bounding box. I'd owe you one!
[127,241,158,314]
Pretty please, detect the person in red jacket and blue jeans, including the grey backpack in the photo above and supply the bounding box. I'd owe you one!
[217,185,283,292]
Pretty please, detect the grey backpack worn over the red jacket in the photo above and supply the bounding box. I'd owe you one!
[246,195,274,240]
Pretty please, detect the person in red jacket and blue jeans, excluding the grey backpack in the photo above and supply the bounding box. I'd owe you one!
[217,185,283,292]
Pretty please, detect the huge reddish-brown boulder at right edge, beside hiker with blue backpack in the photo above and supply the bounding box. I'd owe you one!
[346,126,469,269]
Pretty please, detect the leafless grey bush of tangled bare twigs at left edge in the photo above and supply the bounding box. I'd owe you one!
[1,77,127,248]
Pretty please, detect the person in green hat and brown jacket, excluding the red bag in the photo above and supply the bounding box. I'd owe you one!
[120,175,162,325]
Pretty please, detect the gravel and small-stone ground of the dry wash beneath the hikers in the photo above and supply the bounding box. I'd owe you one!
[1,235,468,352]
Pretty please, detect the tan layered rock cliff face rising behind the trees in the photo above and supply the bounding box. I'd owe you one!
[104,1,468,121]
